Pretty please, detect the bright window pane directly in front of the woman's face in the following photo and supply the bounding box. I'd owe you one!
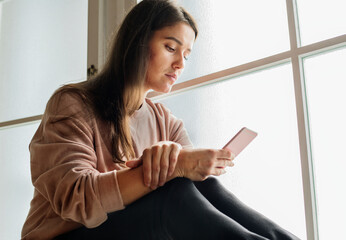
[174,0,289,82]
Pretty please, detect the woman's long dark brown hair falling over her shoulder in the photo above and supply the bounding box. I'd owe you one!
[58,0,198,163]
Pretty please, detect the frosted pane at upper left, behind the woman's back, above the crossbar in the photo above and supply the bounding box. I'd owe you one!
[0,0,88,122]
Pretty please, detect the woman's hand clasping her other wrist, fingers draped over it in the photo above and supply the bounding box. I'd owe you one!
[126,141,181,189]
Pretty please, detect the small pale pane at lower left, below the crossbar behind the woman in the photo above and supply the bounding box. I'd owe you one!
[0,122,39,239]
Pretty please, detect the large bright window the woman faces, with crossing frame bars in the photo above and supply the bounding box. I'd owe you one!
[151,0,346,240]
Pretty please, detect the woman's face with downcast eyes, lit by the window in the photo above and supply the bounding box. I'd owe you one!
[144,22,195,93]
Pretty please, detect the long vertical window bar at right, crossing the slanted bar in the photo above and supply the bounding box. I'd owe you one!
[286,0,318,240]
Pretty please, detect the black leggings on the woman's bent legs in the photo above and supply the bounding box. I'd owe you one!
[57,177,298,240]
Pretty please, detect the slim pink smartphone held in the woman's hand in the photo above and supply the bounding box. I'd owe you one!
[223,127,257,156]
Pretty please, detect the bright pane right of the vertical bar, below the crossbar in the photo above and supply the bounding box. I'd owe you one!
[304,48,346,240]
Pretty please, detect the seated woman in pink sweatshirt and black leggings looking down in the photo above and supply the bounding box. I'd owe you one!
[22,0,297,239]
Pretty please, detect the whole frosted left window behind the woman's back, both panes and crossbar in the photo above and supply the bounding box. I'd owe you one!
[0,0,88,239]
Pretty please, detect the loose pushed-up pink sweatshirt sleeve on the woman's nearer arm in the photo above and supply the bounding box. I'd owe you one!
[30,93,124,228]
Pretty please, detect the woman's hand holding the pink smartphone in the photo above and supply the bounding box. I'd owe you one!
[174,149,234,181]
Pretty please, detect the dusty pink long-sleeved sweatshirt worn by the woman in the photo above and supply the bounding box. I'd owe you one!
[22,93,192,239]
